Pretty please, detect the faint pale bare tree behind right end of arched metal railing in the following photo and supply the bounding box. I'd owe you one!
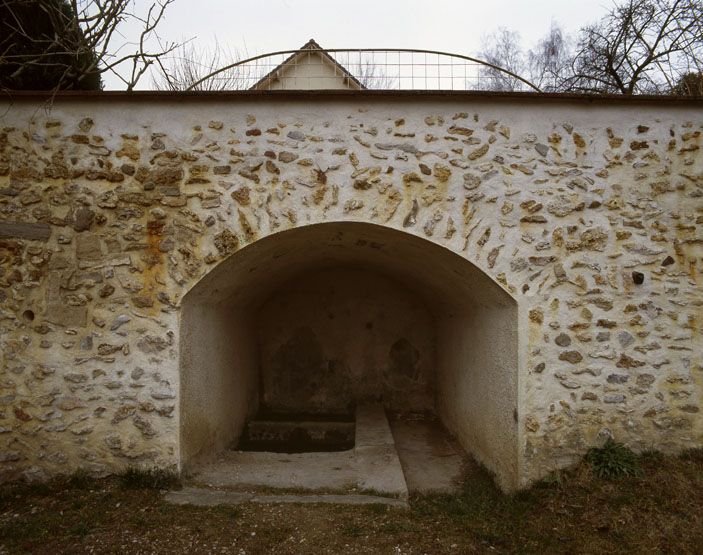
[479,27,527,91]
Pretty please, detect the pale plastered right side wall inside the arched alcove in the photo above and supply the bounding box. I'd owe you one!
[437,306,519,490]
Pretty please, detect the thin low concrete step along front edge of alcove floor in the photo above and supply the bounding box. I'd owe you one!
[164,488,409,509]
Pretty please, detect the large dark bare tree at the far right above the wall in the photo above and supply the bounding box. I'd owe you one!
[565,0,703,94]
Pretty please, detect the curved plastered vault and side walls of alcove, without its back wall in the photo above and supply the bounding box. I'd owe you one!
[180,221,519,489]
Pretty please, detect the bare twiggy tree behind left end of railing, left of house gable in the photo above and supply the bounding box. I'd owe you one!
[153,41,258,91]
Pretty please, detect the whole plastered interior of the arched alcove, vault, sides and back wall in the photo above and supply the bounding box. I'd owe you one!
[180,222,518,488]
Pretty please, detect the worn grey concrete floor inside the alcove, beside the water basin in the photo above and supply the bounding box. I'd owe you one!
[167,405,468,506]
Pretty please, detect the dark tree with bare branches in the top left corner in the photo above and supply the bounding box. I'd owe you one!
[0,0,176,90]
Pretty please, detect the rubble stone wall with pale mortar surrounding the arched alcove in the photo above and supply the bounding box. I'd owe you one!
[0,93,703,485]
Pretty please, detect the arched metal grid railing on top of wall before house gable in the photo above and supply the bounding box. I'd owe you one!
[185,48,541,92]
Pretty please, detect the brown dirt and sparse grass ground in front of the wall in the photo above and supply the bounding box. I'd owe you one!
[0,451,703,554]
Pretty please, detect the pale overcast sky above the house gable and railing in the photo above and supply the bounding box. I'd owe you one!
[104,0,612,89]
